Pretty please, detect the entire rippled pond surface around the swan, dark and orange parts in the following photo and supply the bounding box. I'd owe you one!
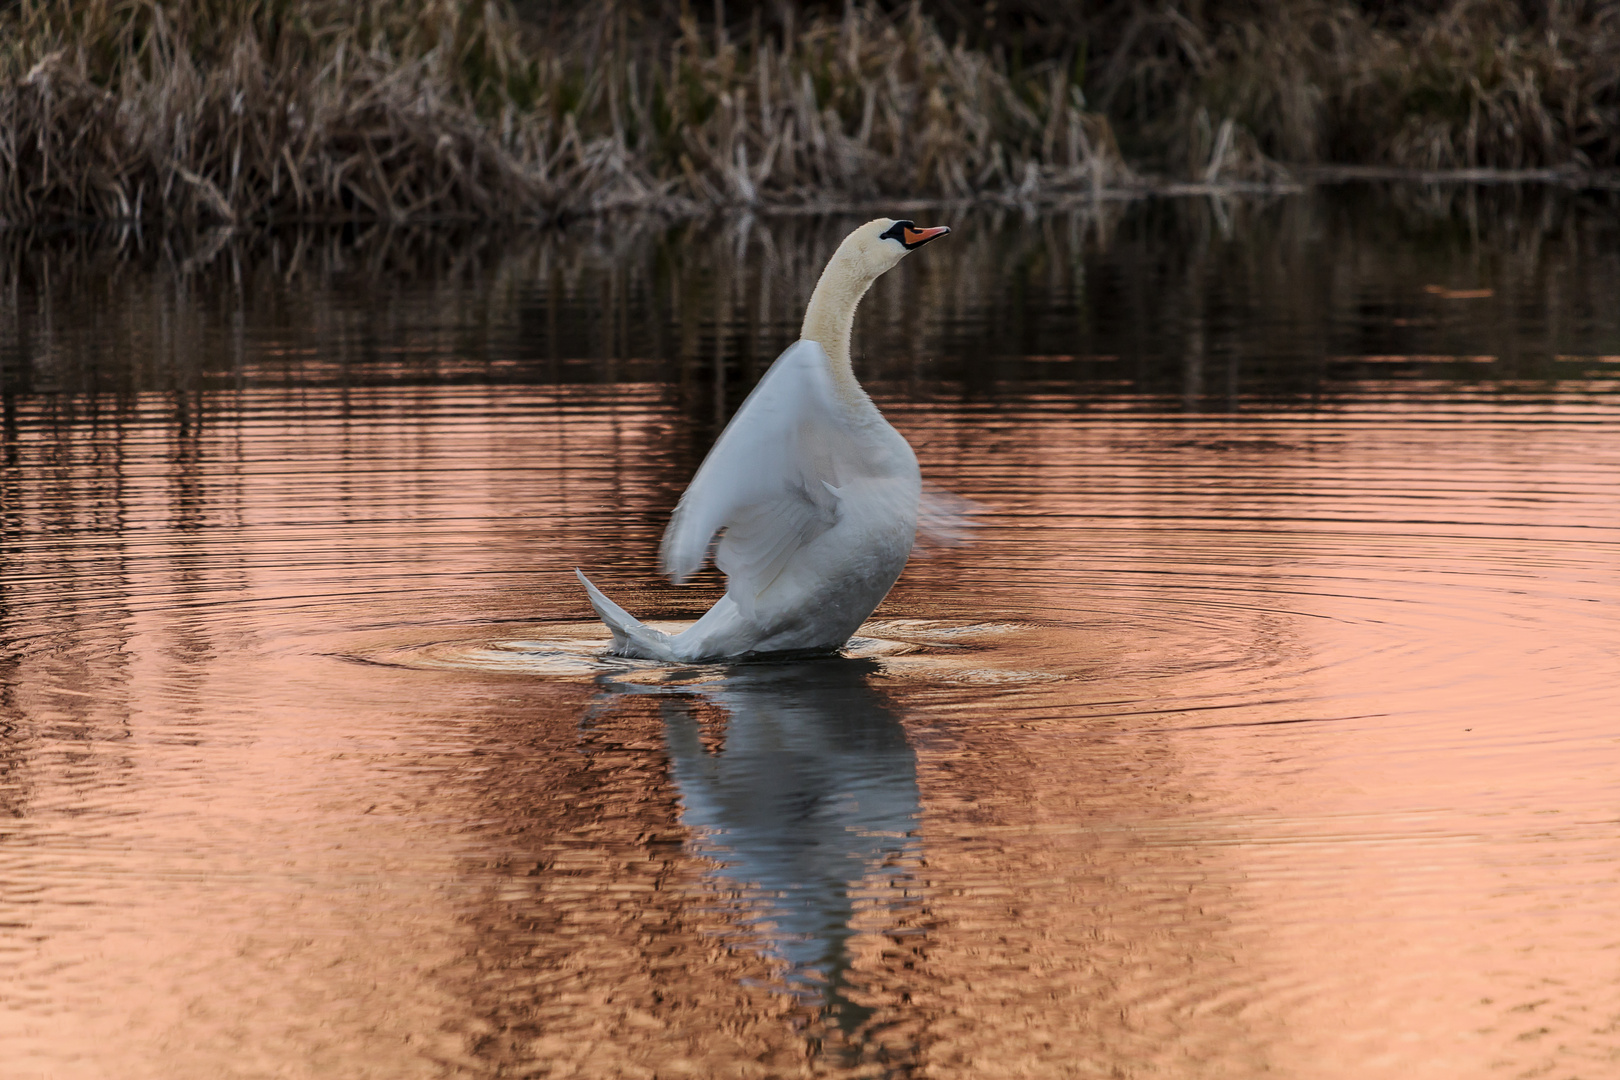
[0,188,1620,1080]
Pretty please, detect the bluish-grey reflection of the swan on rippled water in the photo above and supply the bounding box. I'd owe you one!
[602,657,919,1027]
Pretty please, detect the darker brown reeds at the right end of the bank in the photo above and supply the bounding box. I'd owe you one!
[1097,0,1620,173]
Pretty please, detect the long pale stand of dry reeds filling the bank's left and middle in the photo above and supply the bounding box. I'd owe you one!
[0,0,1128,223]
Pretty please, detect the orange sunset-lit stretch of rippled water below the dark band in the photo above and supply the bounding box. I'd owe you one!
[0,384,1620,1078]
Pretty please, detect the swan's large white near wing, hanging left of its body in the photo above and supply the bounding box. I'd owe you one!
[661,342,851,604]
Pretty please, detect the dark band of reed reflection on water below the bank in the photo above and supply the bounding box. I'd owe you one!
[9,186,1620,417]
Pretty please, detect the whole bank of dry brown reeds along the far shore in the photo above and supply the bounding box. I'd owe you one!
[0,0,1620,225]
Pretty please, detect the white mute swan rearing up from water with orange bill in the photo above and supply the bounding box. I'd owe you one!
[575,217,951,661]
